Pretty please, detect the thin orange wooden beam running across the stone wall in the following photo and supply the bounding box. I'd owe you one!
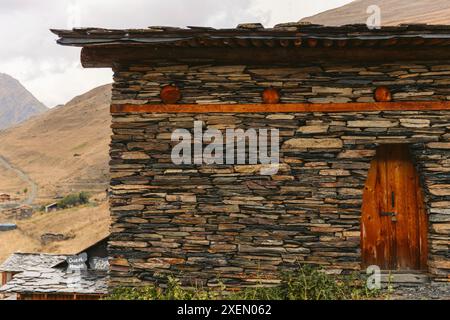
[111,101,450,114]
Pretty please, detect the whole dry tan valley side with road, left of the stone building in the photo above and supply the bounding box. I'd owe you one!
[0,79,111,263]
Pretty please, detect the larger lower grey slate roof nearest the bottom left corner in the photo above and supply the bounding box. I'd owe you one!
[0,267,108,294]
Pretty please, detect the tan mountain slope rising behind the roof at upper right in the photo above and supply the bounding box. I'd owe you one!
[302,0,450,26]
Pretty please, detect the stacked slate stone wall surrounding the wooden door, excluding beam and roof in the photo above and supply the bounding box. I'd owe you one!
[109,62,450,286]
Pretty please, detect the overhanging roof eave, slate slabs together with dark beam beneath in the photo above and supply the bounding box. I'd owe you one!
[52,24,450,67]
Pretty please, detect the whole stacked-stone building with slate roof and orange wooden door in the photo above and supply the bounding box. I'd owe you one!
[53,23,450,286]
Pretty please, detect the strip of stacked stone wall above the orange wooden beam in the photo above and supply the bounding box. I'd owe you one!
[113,62,450,104]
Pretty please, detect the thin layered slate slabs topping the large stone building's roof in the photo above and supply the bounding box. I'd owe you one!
[52,22,450,48]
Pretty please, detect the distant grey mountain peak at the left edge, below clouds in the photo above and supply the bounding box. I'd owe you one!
[0,73,48,130]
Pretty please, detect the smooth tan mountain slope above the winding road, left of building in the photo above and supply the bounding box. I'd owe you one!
[0,85,111,201]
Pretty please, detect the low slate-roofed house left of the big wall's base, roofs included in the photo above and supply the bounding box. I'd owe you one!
[0,239,109,300]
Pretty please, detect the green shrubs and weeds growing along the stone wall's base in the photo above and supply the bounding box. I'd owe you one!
[107,266,381,300]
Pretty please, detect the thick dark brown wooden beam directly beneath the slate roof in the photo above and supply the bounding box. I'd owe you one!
[81,45,450,68]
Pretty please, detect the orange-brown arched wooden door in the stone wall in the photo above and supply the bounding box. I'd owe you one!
[361,144,428,270]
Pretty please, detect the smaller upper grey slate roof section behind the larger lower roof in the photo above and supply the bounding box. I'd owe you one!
[0,253,68,272]
